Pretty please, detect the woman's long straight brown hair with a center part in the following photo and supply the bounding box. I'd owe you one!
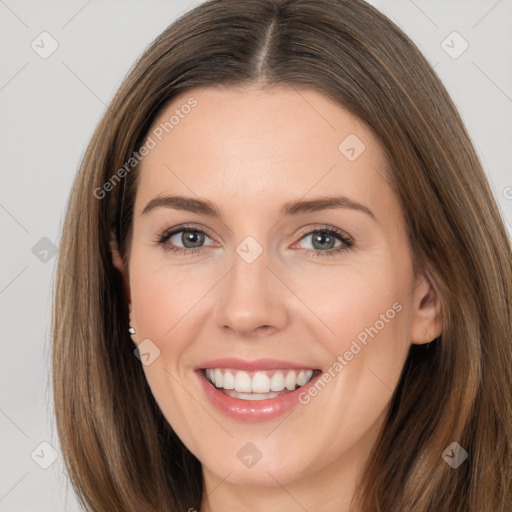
[53,0,512,512]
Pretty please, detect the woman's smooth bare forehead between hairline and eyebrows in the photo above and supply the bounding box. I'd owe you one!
[136,87,390,216]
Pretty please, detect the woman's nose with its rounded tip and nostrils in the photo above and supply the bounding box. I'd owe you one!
[216,245,290,338]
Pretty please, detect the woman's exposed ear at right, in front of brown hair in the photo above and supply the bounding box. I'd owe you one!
[410,272,443,345]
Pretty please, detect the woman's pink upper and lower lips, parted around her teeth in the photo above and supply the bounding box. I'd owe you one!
[194,359,322,423]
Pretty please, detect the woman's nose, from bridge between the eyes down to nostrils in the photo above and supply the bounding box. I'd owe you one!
[217,236,287,335]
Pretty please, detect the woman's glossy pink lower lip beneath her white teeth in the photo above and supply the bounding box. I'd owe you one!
[196,370,321,423]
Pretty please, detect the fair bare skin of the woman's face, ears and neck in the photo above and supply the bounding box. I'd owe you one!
[113,86,441,512]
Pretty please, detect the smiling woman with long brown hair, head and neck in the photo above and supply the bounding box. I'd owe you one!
[53,0,512,512]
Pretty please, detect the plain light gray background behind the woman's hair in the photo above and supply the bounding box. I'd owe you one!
[0,0,512,512]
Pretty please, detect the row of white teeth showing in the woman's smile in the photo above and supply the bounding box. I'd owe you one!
[205,368,313,392]
